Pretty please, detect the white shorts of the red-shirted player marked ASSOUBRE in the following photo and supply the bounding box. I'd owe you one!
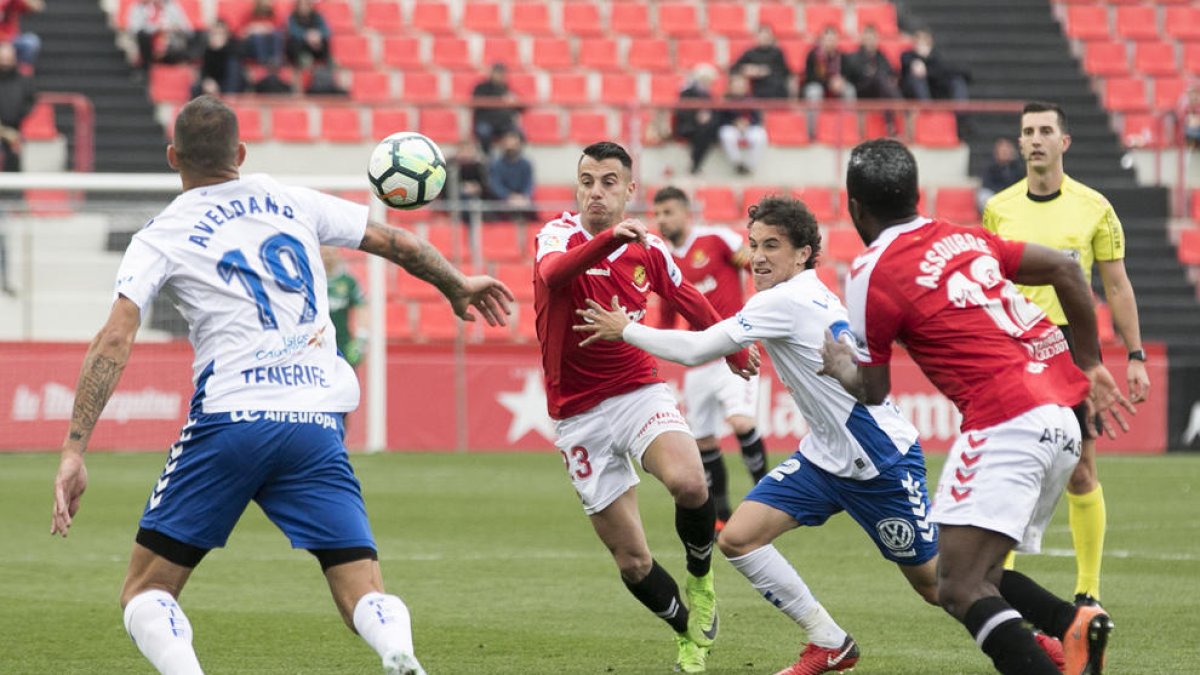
[932,405,1081,552]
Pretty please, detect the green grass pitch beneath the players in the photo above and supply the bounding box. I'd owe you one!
[0,453,1200,675]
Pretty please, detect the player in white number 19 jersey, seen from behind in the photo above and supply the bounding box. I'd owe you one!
[52,96,511,675]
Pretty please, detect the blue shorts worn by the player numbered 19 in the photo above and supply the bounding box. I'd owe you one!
[139,411,376,549]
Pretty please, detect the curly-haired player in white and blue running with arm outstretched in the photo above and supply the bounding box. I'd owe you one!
[576,196,937,674]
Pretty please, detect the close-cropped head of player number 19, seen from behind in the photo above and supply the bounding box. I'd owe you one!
[170,95,239,175]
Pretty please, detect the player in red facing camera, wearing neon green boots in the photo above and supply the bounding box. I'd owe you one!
[534,142,757,673]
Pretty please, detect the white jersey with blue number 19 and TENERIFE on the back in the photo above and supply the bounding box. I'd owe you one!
[116,174,367,413]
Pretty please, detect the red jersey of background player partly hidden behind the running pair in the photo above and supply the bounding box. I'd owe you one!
[660,225,745,328]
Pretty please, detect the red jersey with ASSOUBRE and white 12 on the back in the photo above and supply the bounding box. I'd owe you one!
[846,219,1088,431]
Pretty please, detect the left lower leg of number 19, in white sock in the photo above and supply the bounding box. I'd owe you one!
[121,543,203,675]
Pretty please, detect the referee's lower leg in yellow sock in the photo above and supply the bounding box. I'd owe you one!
[1067,438,1108,604]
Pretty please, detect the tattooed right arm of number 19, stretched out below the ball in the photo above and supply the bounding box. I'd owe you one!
[359,222,514,325]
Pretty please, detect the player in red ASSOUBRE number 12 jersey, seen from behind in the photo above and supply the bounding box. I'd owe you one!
[824,139,1133,675]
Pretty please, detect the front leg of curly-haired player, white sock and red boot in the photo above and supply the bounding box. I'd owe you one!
[718,501,858,669]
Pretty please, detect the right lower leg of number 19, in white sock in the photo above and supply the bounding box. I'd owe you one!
[325,558,425,675]
